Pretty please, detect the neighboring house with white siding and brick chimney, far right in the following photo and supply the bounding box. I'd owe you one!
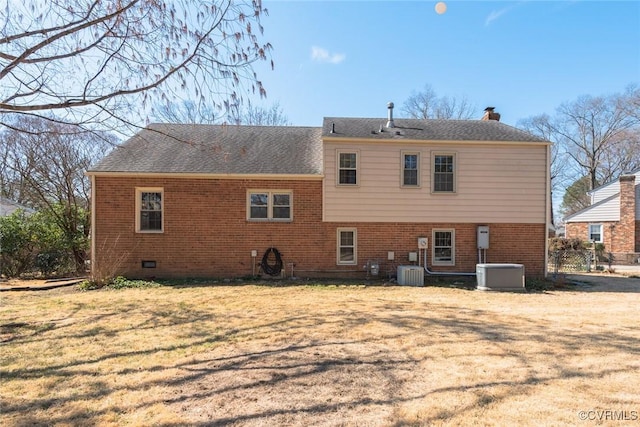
[565,169,640,262]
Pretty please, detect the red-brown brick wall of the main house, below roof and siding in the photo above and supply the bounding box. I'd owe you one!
[93,176,546,278]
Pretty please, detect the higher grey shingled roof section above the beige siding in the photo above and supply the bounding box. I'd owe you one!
[322,117,549,143]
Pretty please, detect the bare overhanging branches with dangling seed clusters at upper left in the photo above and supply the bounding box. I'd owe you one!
[0,0,273,135]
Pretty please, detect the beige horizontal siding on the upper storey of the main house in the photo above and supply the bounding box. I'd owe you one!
[324,142,547,224]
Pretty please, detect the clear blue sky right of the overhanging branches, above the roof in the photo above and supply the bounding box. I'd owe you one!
[250,0,640,126]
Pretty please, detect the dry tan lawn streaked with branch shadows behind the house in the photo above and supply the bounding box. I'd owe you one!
[0,278,640,426]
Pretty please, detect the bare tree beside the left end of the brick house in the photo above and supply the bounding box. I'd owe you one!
[0,116,116,270]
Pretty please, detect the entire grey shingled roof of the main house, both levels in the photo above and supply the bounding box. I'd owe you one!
[89,117,549,176]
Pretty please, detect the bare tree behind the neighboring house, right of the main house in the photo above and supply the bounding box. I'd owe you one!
[518,85,640,222]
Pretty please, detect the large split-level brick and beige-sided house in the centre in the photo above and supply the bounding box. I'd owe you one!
[88,104,550,277]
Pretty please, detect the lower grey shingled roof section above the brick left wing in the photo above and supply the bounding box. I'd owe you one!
[89,124,322,175]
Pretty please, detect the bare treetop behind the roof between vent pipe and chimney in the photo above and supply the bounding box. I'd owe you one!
[402,84,476,119]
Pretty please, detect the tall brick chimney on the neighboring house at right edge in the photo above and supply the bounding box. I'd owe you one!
[615,175,640,254]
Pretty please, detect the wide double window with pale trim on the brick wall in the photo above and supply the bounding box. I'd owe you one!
[247,190,293,221]
